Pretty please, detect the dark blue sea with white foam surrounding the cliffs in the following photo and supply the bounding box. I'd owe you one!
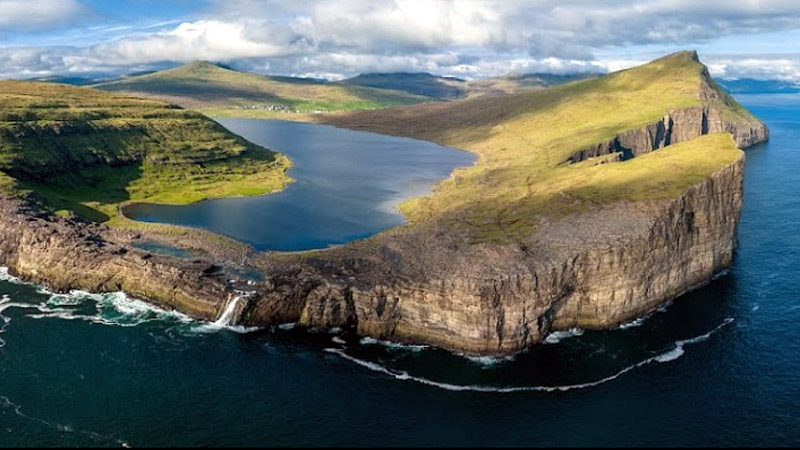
[0,96,800,447]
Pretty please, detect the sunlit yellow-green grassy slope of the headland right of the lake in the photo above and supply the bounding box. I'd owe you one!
[321,52,755,240]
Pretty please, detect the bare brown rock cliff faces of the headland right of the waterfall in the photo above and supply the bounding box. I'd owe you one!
[242,103,756,355]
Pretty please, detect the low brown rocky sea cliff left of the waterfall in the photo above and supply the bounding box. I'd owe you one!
[0,197,229,320]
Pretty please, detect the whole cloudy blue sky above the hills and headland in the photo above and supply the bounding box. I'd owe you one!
[0,0,800,83]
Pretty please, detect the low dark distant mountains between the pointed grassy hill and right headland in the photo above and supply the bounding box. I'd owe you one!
[340,72,596,101]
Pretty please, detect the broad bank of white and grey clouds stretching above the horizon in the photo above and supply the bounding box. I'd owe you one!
[0,0,800,79]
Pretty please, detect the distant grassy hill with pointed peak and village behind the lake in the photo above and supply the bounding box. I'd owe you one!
[95,62,430,117]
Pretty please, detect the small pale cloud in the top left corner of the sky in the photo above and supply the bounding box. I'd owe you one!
[0,0,84,31]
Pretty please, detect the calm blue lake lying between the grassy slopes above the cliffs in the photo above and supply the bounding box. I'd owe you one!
[125,119,475,251]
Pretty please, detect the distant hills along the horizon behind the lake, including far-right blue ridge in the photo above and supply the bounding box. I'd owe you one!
[28,61,800,117]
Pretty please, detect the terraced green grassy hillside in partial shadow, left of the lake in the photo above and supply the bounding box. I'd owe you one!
[0,81,289,221]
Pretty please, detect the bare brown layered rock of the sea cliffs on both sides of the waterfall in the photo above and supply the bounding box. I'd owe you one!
[0,101,768,355]
